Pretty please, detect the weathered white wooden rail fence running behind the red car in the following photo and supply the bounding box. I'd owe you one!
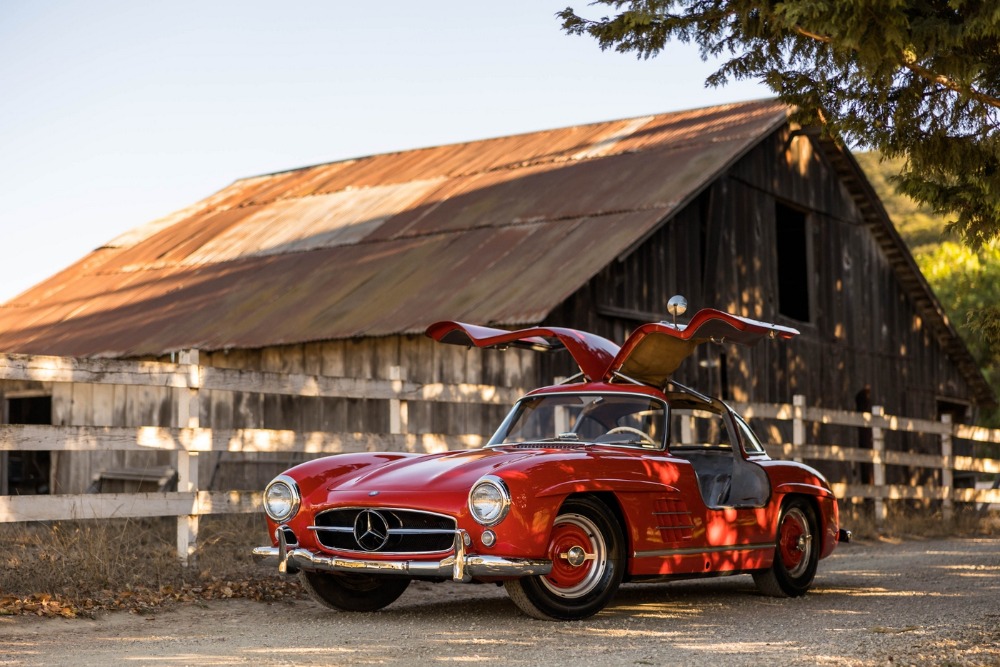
[0,351,1000,562]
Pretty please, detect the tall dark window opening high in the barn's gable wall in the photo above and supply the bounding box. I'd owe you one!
[774,202,812,322]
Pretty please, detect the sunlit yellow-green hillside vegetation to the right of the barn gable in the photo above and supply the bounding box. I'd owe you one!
[854,153,1000,427]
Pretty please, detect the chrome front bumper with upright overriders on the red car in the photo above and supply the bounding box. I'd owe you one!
[253,528,552,582]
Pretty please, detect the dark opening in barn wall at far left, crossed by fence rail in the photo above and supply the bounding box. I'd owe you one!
[0,396,52,496]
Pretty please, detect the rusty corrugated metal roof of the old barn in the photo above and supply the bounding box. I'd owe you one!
[0,101,787,356]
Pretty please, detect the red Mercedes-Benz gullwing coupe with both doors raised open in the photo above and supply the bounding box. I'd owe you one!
[254,309,849,620]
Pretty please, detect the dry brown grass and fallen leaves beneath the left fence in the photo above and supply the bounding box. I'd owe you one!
[0,515,302,616]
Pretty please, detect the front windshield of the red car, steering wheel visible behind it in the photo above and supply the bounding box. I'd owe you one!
[489,394,666,449]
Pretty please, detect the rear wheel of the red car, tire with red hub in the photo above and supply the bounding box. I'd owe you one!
[753,498,821,598]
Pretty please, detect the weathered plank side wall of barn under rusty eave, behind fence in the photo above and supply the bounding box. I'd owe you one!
[0,335,539,493]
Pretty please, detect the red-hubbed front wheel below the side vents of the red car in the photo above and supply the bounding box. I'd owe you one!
[504,498,625,621]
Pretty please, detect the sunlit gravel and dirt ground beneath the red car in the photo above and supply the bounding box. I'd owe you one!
[0,538,1000,666]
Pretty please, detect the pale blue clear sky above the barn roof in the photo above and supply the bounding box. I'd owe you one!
[0,0,771,302]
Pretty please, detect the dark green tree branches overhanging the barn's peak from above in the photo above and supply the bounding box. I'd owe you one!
[559,0,1000,248]
